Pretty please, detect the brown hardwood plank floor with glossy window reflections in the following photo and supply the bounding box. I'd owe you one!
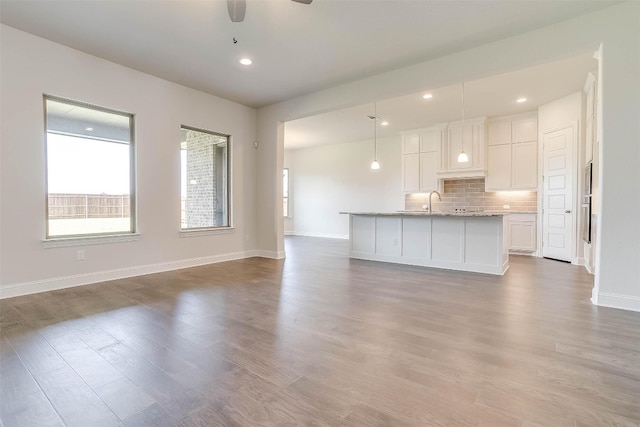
[0,237,640,427]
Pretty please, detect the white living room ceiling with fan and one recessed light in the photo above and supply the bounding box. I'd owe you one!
[0,0,617,107]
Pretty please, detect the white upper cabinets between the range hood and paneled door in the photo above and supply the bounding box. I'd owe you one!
[485,114,538,191]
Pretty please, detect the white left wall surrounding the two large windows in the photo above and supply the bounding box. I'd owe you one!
[0,25,256,296]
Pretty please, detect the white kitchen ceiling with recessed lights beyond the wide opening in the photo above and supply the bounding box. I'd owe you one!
[284,52,597,149]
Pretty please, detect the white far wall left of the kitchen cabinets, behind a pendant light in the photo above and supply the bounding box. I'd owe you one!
[285,136,404,238]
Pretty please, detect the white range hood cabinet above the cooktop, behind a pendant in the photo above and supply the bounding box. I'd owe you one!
[438,118,486,178]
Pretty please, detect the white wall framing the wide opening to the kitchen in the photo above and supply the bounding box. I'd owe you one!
[258,1,640,311]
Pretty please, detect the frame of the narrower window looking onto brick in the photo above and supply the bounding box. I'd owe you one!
[178,124,234,231]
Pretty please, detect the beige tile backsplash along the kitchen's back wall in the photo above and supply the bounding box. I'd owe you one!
[404,178,538,212]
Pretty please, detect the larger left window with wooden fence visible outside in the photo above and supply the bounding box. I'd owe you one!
[44,96,135,239]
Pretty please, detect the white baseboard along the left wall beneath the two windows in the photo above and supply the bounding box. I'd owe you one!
[0,250,268,299]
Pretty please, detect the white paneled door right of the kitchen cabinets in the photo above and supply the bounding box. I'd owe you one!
[542,125,575,262]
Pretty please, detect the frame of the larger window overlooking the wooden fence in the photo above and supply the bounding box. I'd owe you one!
[42,93,139,241]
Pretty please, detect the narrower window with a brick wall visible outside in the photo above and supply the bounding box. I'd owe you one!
[180,126,229,230]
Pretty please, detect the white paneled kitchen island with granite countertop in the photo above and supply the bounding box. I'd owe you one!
[340,211,509,275]
